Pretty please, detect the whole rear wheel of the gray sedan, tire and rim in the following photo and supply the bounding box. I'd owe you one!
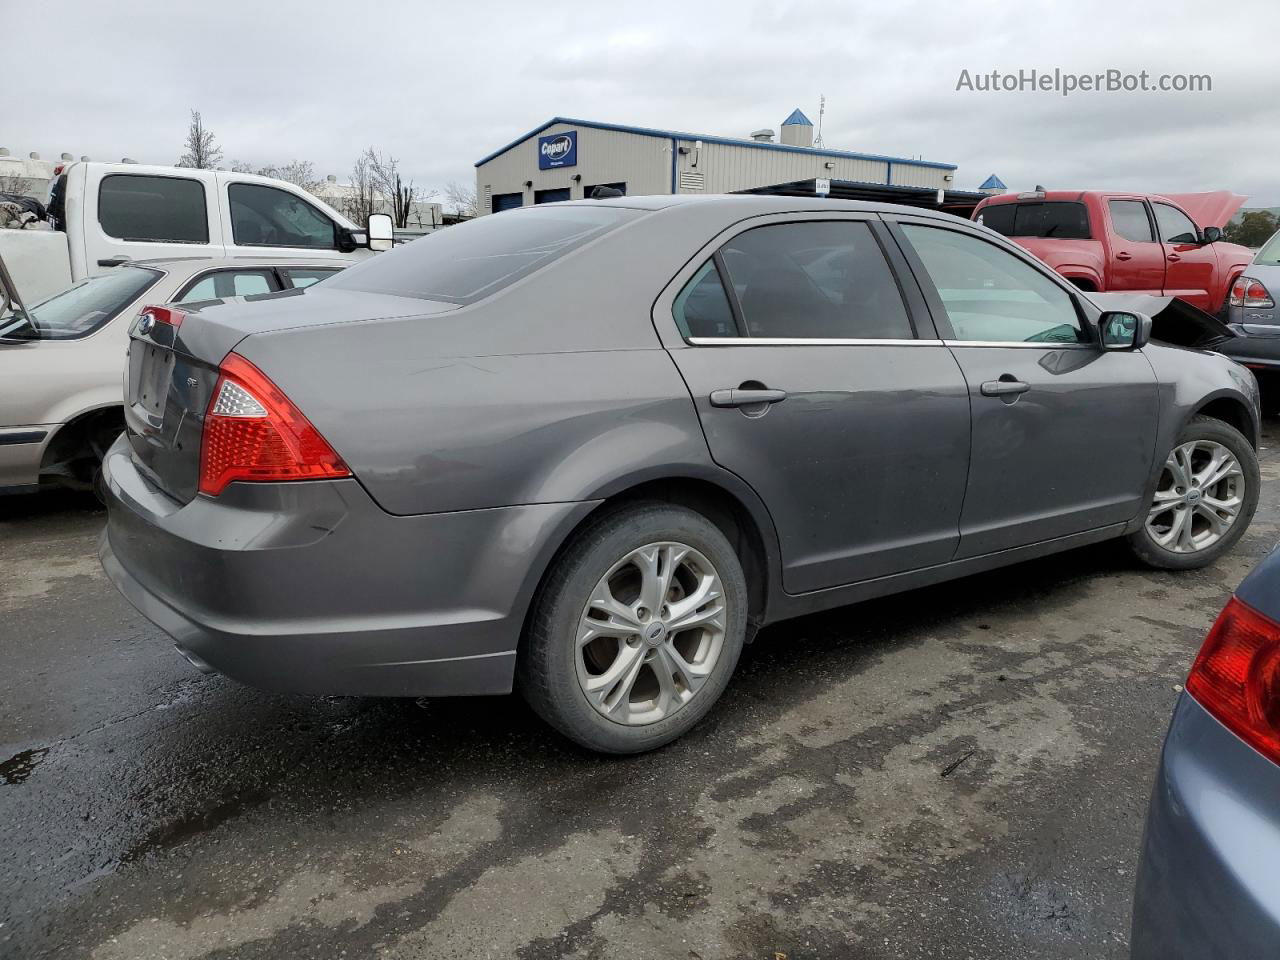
[517,502,748,754]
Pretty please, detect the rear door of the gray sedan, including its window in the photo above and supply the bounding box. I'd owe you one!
[654,216,969,593]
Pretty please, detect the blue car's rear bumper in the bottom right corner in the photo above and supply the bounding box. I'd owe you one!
[1130,694,1280,960]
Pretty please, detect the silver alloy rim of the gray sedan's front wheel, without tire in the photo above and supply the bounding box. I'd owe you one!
[1147,440,1244,553]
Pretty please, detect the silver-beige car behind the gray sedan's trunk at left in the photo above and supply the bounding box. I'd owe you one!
[0,257,352,493]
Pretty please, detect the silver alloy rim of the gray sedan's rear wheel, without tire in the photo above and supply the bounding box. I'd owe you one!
[575,541,726,726]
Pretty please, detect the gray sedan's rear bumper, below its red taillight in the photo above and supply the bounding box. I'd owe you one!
[99,438,594,696]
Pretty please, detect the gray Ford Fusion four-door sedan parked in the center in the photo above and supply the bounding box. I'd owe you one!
[101,196,1258,753]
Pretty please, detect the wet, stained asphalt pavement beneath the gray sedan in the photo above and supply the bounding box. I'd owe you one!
[0,421,1280,960]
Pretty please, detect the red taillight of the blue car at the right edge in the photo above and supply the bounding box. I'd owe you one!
[1187,596,1280,763]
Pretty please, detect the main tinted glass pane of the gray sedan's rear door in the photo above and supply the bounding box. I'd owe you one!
[721,220,915,339]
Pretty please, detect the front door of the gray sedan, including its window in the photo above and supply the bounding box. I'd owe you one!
[895,218,1157,558]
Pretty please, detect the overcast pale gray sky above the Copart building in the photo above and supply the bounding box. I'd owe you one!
[10,0,1280,206]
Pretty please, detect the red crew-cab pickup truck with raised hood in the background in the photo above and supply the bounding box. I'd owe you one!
[973,189,1253,314]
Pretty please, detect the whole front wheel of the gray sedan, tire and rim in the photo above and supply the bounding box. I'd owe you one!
[1128,416,1261,570]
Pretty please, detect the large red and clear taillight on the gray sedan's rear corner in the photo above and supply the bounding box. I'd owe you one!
[200,353,351,497]
